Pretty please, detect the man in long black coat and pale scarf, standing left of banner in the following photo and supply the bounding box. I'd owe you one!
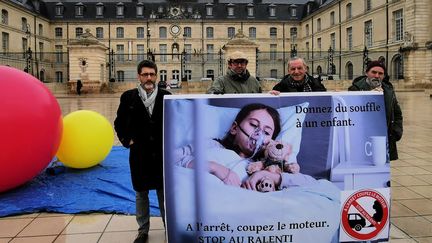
[114,60,171,242]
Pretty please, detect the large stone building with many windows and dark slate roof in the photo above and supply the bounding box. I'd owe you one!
[0,0,432,86]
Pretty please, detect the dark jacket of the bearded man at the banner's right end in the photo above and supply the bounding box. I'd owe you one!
[348,76,403,160]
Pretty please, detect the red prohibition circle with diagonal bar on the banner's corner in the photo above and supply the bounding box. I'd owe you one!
[341,190,389,240]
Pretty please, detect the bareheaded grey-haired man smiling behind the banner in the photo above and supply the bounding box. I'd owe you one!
[270,57,327,95]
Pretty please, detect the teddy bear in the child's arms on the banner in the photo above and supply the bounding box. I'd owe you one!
[246,140,300,192]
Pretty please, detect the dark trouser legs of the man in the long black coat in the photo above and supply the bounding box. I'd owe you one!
[135,189,165,234]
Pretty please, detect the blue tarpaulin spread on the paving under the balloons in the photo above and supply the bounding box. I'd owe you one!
[0,146,160,217]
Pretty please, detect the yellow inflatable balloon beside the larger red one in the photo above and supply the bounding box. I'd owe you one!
[57,110,114,169]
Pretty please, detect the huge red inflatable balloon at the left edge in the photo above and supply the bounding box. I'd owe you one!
[0,66,63,192]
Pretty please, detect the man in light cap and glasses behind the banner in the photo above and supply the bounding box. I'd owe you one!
[207,51,261,94]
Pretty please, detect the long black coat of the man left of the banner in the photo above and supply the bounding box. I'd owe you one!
[114,88,171,191]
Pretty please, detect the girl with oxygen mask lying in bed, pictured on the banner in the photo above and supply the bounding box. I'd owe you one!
[175,103,315,192]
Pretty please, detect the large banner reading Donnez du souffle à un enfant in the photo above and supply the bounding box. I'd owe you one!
[164,92,390,243]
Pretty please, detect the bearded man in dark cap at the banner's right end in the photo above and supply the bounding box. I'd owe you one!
[348,61,403,160]
